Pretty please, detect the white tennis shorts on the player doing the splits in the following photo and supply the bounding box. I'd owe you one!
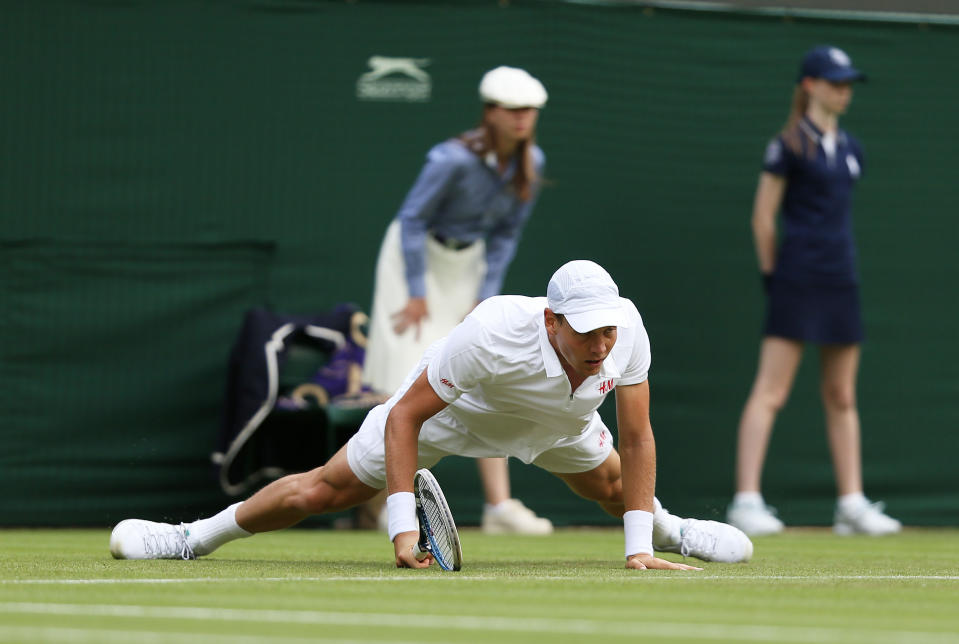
[346,405,613,489]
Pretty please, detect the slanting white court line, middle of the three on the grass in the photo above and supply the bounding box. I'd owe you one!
[0,602,959,644]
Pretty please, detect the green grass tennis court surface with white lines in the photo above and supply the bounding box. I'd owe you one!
[0,529,959,644]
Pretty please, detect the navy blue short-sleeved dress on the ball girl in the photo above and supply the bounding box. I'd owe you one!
[763,118,863,344]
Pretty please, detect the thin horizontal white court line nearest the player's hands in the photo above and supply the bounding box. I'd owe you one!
[0,572,959,586]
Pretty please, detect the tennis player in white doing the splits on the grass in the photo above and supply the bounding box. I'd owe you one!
[110,260,752,570]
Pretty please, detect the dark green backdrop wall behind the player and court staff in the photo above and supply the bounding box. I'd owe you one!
[0,0,959,525]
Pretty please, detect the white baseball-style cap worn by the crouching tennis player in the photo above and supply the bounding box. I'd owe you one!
[546,259,629,333]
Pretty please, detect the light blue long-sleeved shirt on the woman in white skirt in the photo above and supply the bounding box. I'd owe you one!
[396,140,545,300]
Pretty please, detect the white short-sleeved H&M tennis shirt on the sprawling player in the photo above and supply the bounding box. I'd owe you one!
[420,295,650,463]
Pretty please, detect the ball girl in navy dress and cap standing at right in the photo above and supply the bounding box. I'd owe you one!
[728,46,902,535]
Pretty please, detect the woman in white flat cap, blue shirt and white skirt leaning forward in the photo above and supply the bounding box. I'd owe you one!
[363,67,552,534]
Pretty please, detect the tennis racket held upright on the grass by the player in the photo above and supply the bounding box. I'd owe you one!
[413,469,463,570]
